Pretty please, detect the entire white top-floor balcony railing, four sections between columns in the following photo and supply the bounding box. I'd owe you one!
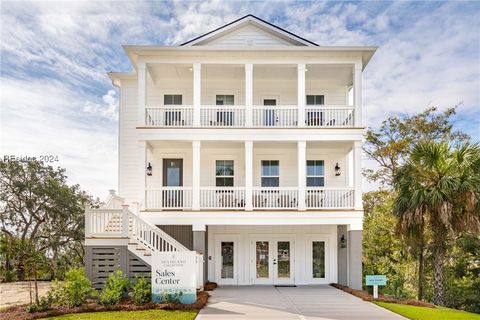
[145,105,355,128]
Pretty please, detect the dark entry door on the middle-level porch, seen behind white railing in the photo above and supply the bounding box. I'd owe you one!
[162,159,183,208]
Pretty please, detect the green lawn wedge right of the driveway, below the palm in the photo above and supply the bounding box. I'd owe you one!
[374,302,480,320]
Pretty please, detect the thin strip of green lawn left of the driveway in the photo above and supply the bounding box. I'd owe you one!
[42,310,197,320]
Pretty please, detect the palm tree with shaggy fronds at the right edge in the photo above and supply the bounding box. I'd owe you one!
[393,141,480,305]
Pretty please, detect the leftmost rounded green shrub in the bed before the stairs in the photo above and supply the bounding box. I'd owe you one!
[51,268,93,307]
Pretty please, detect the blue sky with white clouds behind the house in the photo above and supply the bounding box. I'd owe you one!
[0,0,480,197]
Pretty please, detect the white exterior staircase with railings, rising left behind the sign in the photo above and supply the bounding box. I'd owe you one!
[85,192,203,287]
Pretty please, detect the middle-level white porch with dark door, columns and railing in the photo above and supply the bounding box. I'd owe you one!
[132,140,361,211]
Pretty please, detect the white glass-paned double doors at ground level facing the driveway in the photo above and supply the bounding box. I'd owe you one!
[252,239,294,284]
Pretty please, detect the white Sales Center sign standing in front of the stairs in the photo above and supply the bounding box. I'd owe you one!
[152,251,197,304]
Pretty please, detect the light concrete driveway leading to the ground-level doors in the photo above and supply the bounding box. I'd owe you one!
[196,285,406,320]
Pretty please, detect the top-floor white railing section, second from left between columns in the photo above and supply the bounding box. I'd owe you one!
[200,106,245,127]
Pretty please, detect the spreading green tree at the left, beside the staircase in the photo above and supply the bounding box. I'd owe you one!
[0,161,94,280]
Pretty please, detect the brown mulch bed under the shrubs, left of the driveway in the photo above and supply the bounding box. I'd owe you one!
[0,291,210,320]
